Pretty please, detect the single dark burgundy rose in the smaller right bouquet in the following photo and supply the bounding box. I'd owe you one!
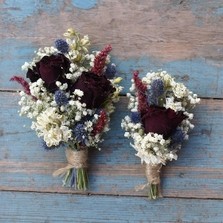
[142,106,187,139]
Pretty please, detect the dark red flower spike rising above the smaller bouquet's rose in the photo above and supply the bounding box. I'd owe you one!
[133,71,149,113]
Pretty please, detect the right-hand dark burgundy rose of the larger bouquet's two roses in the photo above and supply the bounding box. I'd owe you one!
[71,72,115,109]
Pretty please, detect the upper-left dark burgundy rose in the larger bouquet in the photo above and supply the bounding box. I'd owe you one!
[26,54,70,92]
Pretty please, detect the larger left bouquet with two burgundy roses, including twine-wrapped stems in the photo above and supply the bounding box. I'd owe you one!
[11,29,121,190]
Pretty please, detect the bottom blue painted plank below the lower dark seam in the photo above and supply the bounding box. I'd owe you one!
[0,192,223,223]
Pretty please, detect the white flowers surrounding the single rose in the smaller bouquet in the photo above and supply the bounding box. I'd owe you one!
[121,71,200,165]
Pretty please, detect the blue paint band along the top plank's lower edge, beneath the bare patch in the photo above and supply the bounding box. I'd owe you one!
[0,39,223,98]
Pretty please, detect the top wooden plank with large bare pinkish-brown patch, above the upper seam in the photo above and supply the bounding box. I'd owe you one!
[0,0,223,98]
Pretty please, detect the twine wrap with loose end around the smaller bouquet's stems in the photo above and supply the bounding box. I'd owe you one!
[135,164,162,197]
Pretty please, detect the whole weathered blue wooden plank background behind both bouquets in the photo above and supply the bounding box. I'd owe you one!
[0,0,223,223]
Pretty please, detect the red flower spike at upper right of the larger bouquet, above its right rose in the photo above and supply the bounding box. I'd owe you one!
[91,45,112,75]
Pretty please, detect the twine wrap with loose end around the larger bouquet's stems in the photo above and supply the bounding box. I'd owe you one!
[53,148,88,177]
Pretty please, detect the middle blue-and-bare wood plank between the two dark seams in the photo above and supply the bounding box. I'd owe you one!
[0,92,223,199]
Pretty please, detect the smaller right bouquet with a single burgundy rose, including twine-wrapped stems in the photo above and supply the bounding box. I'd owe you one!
[122,71,200,199]
